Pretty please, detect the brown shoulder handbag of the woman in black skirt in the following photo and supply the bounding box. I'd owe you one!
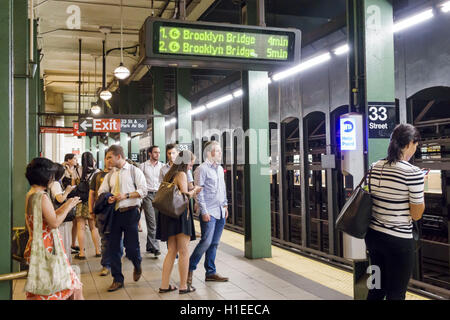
[152,181,189,218]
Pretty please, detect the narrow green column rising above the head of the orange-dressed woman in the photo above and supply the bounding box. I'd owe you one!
[28,20,40,160]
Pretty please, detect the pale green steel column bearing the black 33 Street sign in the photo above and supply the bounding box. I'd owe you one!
[364,0,395,165]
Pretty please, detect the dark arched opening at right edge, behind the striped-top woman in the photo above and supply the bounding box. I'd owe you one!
[407,87,450,289]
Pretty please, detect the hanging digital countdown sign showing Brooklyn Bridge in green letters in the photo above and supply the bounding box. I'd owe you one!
[140,17,301,70]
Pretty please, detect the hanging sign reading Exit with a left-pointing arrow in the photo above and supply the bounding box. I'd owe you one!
[79,118,147,132]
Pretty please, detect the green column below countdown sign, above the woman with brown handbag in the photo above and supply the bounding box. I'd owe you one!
[176,69,192,143]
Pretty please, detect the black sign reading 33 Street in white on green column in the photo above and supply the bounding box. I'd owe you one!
[367,102,396,138]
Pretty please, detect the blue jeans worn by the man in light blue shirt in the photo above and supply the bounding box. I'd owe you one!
[189,216,225,276]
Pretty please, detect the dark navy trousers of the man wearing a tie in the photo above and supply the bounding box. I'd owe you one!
[108,209,142,283]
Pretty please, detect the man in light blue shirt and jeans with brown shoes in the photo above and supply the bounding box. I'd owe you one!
[187,141,228,284]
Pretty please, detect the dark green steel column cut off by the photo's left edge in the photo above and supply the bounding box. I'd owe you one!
[0,0,13,300]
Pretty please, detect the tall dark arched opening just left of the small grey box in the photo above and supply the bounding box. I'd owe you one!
[304,112,329,253]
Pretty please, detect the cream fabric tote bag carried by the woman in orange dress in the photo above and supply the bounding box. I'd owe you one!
[25,192,72,295]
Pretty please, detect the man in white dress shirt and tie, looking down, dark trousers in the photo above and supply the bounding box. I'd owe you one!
[98,145,147,291]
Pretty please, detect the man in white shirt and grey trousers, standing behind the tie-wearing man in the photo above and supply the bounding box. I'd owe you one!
[139,146,164,258]
